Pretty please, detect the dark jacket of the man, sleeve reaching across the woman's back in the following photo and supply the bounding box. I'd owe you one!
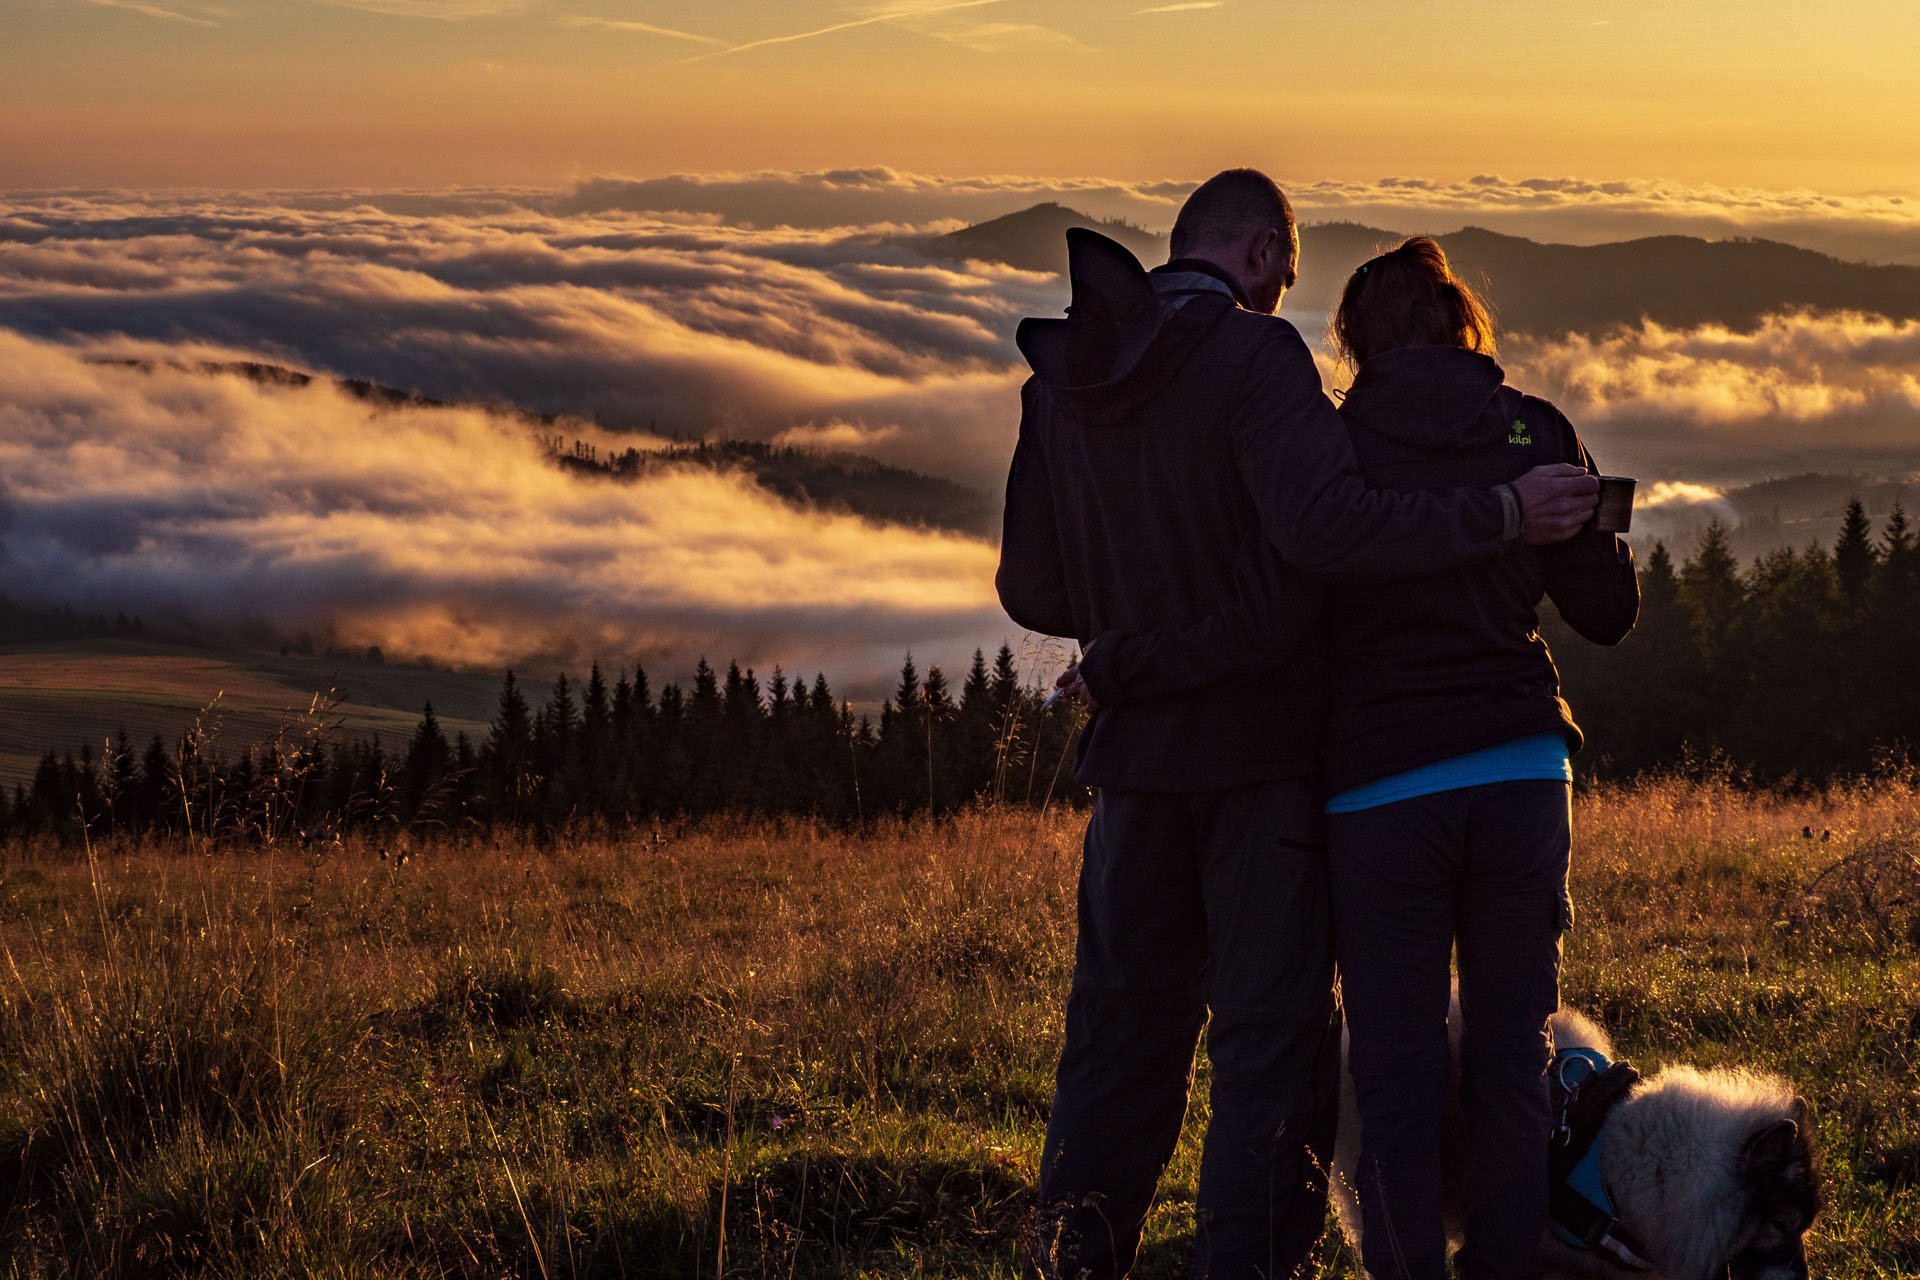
[996,230,1503,793]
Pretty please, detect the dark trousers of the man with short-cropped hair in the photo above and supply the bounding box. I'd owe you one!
[1041,779,1340,1280]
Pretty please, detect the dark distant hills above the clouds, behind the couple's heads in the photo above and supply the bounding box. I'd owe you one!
[929,205,1920,334]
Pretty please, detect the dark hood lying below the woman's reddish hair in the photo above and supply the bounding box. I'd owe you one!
[1340,347,1507,451]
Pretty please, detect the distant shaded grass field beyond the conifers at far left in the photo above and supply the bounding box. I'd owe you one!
[0,639,499,791]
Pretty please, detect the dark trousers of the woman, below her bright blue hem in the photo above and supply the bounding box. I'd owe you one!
[1327,781,1572,1280]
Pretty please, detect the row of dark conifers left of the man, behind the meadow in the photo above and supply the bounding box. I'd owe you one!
[0,645,1089,842]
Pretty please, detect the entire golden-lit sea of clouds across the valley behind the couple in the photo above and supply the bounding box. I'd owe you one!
[0,169,1920,689]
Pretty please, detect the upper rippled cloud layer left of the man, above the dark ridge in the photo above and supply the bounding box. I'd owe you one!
[0,196,1064,486]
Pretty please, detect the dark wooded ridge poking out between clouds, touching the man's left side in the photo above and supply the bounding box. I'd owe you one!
[547,438,1000,537]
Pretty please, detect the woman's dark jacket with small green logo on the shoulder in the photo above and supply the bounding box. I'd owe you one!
[1328,347,1640,791]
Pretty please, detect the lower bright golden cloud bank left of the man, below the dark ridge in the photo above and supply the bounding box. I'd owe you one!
[0,334,1010,687]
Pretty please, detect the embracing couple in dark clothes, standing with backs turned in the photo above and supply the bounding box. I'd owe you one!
[998,169,1638,1280]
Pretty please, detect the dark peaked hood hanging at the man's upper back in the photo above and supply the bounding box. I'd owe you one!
[1014,226,1235,422]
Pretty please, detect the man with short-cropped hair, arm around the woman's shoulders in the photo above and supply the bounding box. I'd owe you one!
[996,169,1596,1280]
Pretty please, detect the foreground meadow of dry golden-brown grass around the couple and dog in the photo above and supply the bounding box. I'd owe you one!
[0,781,1920,1280]
